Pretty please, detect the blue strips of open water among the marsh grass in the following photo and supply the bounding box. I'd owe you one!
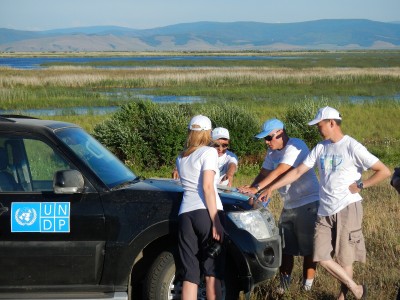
[0,55,400,116]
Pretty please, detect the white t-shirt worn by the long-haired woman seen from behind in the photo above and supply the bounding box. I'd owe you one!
[176,146,223,214]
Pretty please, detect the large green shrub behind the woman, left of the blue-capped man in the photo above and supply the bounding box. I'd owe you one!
[93,101,263,171]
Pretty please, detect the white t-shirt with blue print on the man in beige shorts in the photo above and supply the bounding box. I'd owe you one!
[303,135,379,216]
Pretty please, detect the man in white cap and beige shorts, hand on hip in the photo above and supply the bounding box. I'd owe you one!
[260,106,391,300]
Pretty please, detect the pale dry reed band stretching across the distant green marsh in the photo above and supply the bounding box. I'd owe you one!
[0,67,400,88]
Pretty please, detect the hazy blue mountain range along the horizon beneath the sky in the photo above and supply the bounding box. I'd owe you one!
[0,19,400,52]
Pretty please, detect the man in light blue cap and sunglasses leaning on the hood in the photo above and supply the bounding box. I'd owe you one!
[239,119,319,293]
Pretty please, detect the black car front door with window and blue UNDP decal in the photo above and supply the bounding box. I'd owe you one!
[0,133,105,291]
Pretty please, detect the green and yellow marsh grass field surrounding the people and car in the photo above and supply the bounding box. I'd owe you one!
[0,51,400,300]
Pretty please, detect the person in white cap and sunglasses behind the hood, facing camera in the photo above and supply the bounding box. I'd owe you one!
[211,127,238,186]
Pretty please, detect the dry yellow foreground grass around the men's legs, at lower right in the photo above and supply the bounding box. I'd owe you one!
[237,172,400,300]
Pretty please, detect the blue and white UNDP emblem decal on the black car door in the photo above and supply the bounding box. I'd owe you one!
[11,202,70,232]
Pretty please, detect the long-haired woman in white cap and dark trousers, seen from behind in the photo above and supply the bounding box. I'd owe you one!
[176,115,225,299]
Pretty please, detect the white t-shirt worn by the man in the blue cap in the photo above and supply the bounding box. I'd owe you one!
[262,138,319,209]
